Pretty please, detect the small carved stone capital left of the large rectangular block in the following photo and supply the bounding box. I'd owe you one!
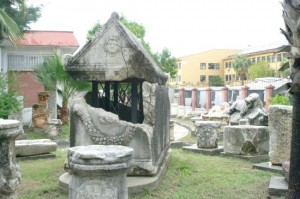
[195,121,222,148]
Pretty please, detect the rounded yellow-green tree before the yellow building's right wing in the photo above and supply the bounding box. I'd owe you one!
[248,62,274,80]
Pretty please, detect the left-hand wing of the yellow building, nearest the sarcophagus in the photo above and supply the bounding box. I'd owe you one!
[169,49,241,87]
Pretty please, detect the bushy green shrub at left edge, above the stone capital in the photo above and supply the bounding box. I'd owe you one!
[0,73,21,119]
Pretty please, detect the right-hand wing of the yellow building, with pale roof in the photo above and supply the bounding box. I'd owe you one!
[223,44,287,86]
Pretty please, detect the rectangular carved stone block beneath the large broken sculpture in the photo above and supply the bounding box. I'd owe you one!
[223,125,269,155]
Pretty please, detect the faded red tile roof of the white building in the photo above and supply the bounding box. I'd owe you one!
[20,31,79,47]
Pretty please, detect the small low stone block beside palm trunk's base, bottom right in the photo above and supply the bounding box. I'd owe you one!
[269,176,288,196]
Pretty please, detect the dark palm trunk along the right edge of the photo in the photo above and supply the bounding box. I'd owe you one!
[281,0,300,199]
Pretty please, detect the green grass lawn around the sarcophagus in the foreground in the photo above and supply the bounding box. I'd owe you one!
[17,149,282,199]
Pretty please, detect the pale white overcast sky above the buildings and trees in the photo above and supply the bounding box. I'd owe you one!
[28,0,285,57]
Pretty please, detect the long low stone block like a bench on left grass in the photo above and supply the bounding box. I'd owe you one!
[15,139,57,156]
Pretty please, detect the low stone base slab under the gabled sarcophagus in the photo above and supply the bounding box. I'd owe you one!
[59,149,172,194]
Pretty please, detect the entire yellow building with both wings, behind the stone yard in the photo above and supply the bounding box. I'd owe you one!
[169,44,287,87]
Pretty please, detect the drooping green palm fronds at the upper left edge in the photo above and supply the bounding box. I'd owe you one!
[0,9,23,45]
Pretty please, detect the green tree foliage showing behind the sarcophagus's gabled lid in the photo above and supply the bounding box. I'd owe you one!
[87,16,177,78]
